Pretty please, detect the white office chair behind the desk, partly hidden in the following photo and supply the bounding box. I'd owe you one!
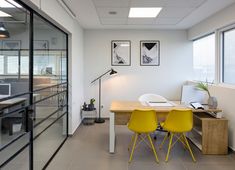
[138,93,167,140]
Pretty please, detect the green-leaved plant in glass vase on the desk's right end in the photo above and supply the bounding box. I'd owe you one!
[196,82,218,109]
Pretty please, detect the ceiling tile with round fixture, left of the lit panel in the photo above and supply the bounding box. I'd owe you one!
[97,8,129,18]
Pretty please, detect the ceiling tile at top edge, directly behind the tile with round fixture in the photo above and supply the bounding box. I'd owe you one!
[93,0,130,7]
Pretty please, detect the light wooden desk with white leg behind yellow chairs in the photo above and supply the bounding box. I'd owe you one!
[109,101,222,153]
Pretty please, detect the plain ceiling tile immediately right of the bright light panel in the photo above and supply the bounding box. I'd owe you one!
[158,7,195,18]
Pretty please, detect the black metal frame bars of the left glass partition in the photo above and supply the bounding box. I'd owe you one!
[0,0,69,170]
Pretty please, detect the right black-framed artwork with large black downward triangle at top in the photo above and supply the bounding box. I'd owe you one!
[140,41,160,66]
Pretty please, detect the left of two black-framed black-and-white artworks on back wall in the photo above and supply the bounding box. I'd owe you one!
[111,40,131,66]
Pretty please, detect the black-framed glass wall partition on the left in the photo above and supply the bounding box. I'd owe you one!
[0,0,68,170]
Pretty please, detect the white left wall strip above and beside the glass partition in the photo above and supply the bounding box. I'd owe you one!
[23,0,84,134]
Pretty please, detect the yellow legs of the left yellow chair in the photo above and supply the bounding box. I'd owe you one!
[129,133,159,163]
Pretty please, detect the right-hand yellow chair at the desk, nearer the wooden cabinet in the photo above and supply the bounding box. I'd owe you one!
[160,109,196,162]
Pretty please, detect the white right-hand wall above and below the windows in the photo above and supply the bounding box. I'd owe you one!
[188,4,235,150]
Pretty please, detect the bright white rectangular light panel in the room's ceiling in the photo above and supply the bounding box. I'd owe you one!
[129,7,162,18]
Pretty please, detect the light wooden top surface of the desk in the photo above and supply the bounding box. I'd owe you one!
[110,101,222,112]
